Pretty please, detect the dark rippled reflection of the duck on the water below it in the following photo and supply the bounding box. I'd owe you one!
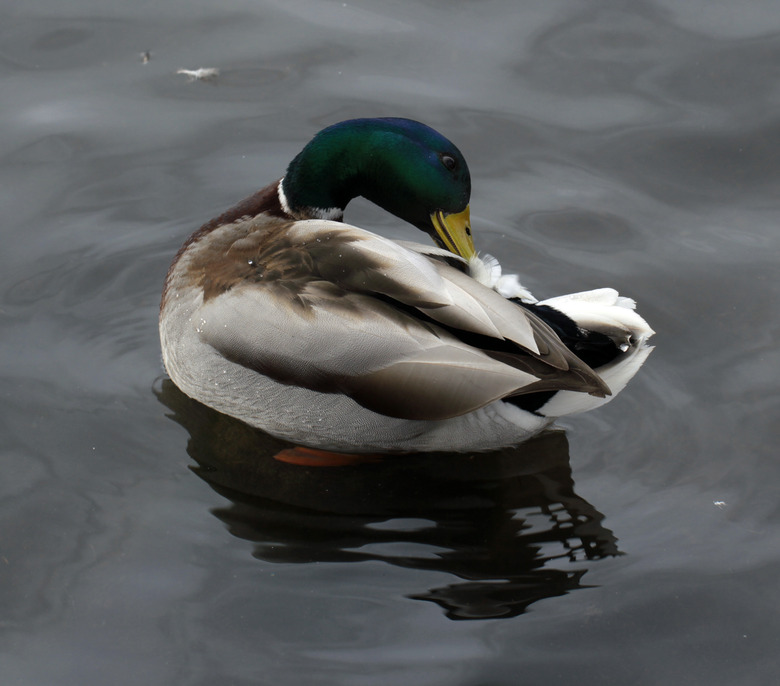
[158,379,618,619]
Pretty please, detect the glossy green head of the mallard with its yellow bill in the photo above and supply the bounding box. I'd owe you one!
[282,118,475,259]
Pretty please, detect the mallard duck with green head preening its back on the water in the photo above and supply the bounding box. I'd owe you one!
[160,118,653,453]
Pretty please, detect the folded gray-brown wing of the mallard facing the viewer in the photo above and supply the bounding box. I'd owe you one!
[193,220,609,419]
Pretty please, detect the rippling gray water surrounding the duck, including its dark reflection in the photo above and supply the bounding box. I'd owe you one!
[0,0,780,686]
